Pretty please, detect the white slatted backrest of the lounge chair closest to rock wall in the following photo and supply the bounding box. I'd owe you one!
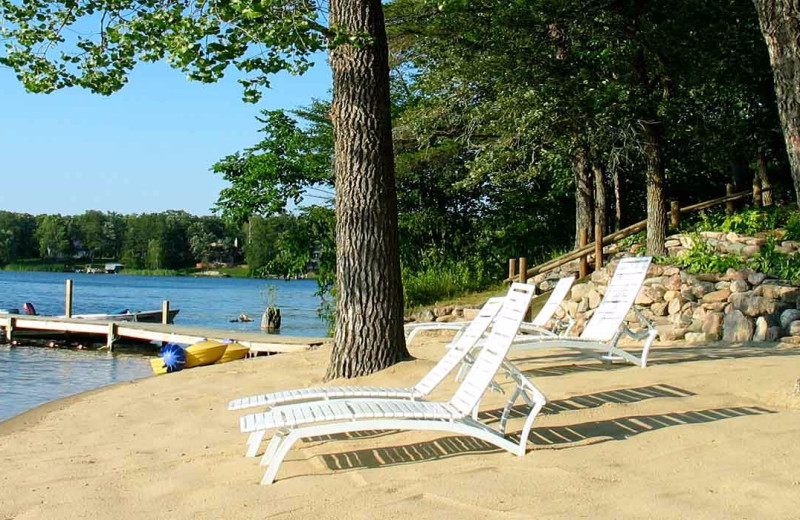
[580,256,652,342]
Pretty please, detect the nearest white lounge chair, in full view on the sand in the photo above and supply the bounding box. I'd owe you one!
[240,284,546,484]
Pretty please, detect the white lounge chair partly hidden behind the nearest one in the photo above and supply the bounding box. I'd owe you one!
[228,297,503,416]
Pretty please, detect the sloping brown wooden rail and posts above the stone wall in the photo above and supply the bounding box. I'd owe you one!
[504,187,762,283]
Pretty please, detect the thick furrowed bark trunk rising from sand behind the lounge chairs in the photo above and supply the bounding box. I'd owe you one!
[326,0,408,379]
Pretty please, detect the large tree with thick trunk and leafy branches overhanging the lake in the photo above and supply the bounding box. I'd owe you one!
[0,0,408,377]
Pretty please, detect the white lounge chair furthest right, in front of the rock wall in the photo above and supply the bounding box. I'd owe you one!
[513,257,658,368]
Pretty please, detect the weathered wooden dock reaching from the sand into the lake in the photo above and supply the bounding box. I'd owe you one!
[0,314,331,353]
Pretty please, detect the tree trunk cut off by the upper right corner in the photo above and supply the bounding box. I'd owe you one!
[753,0,800,204]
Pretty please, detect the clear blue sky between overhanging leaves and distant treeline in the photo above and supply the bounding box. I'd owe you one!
[0,55,331,215]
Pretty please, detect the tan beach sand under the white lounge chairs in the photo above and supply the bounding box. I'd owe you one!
[0,333,800,520]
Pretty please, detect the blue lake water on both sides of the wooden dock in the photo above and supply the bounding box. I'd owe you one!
[0,271,327,421]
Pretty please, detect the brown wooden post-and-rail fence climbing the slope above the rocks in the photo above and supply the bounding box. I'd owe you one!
[504,179,763,283]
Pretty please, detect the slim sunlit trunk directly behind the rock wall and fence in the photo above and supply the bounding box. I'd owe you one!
[642,121,667,256]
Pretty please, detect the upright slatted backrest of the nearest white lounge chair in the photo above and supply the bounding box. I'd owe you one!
[450,283,534,415]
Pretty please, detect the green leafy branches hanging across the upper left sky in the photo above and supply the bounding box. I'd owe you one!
[0,0,327,101]
